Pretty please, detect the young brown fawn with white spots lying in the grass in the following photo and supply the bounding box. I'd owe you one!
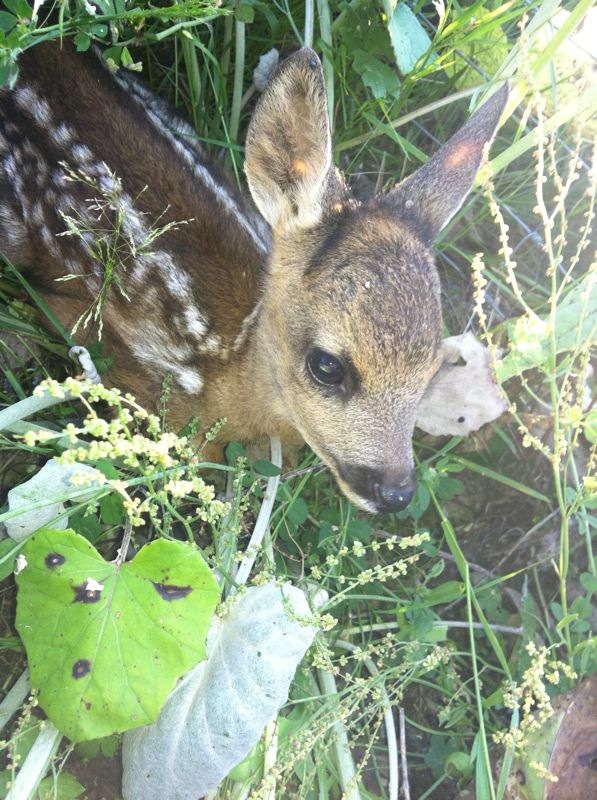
[0,42,507,512]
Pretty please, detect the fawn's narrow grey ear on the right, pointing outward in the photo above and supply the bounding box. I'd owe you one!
[378,85,508,246]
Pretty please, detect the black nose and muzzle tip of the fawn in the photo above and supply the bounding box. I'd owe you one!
[339,464,416,512]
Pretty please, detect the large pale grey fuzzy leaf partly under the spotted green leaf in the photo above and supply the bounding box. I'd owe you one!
[122,583,316,800]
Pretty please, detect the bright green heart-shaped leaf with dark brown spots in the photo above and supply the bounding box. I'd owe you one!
[17,529,219,741]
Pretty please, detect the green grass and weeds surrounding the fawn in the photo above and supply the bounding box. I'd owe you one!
[0,0,597,800]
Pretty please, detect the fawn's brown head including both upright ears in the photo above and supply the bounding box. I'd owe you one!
[245,49,507,511]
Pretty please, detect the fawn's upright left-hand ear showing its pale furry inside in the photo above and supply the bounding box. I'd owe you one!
[245,47,340,229]
